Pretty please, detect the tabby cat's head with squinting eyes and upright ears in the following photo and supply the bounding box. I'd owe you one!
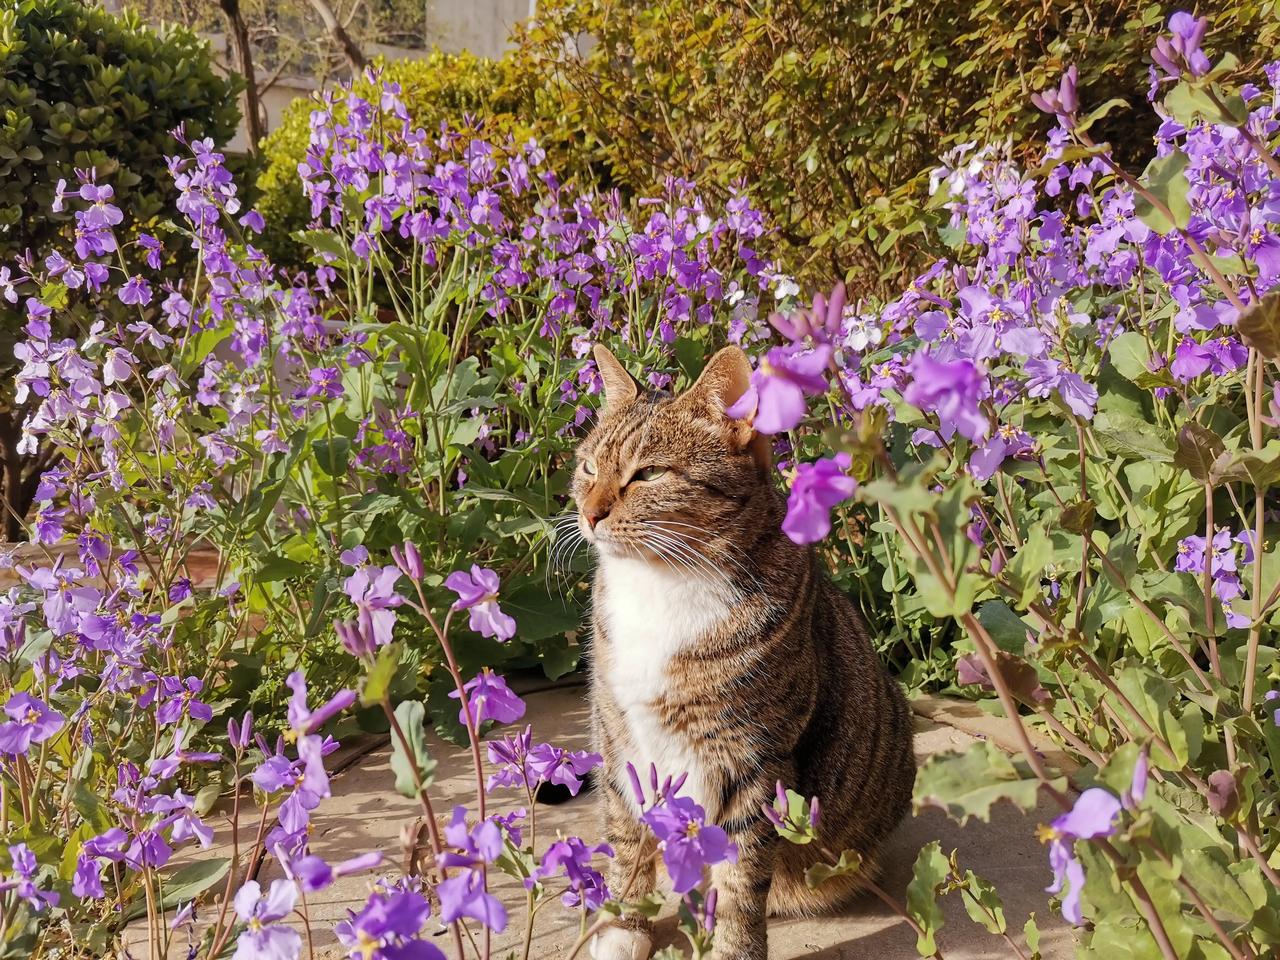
[573,346,773,567]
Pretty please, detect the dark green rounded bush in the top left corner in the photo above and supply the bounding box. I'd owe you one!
[0,0,239,539]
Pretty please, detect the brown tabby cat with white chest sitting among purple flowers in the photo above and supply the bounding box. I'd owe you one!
[573,346,915,960]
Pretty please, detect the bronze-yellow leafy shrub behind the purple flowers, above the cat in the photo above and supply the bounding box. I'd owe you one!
[252,0,1280,296]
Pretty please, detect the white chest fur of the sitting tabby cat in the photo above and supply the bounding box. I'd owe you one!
[598,557,731,818]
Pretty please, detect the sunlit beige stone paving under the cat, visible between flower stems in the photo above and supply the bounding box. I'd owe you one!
[128,685,1071,960]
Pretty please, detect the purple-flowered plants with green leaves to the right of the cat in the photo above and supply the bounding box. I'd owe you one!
[747,13,1280,959]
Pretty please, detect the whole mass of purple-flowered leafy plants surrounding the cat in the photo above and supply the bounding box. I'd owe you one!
[0,7,1280,960]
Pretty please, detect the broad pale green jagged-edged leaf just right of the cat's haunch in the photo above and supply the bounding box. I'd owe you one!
[913,740,1066,826]
